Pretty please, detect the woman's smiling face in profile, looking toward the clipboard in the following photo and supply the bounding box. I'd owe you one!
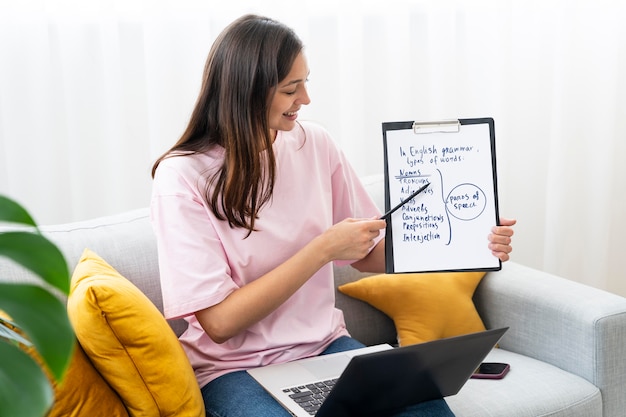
[269,52,311,136]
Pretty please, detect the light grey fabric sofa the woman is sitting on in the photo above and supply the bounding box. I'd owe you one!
[0,176,626,417]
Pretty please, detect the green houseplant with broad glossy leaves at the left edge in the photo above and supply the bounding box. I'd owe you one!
[0,195,74,417]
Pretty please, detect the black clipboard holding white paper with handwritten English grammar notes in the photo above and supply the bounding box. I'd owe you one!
[382,118,502,274]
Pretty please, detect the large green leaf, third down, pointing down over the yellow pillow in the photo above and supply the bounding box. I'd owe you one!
[0,283,74,380]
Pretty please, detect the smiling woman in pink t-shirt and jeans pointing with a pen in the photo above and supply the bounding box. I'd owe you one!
[151,15,513,417]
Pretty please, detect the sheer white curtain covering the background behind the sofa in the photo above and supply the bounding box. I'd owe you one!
[0,0,626,295]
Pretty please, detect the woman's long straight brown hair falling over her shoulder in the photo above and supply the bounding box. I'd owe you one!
[152,15,303,233]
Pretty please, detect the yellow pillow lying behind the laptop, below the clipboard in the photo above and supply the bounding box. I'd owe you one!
[339,272,485,346]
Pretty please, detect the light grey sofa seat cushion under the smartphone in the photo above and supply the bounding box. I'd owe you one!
[446,349,602,417]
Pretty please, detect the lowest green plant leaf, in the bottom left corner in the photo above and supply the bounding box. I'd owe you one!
[0,340,54,417]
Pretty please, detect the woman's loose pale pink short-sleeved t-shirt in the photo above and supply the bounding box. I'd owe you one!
[151,123,383,386]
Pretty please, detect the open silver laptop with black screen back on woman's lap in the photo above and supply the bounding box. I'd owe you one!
[248,327,508,417]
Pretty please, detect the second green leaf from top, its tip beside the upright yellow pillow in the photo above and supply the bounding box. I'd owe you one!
[0,232,70,294]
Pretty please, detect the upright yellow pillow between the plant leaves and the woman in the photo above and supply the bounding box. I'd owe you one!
[67,249,205,417]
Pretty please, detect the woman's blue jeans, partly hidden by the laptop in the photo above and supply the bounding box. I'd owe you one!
[202,337,454,417]
